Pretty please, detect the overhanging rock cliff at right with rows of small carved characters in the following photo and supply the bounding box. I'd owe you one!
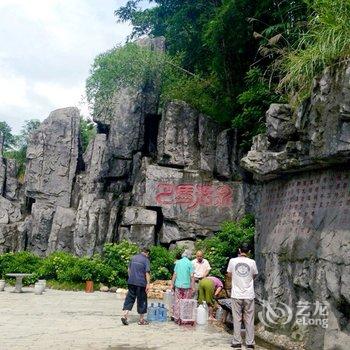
[241,62,350,350]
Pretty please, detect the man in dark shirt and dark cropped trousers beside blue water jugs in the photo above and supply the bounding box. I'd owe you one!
[121,248,150,326]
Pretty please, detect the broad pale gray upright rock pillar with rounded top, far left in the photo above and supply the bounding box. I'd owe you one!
[25,108,79,207]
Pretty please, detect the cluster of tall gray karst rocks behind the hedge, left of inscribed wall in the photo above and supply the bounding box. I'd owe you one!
[0,38,245,256]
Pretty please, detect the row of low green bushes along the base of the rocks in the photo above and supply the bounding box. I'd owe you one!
[0,216,254,290]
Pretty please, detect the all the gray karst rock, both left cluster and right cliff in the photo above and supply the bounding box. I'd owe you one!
[0,38,350,350]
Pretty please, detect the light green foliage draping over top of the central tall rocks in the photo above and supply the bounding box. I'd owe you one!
[86,43,227,120]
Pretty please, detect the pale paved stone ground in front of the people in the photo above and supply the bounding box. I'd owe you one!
[0,287,268,350]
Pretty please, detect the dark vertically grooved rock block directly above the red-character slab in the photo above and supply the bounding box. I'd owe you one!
[158,101,236,179]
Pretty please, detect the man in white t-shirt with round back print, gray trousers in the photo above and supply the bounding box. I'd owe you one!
[227,244,258,349]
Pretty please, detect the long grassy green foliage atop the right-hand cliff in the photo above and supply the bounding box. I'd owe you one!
[280,0,350,102]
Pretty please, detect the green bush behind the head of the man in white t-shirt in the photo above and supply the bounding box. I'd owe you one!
[196,215,255,278]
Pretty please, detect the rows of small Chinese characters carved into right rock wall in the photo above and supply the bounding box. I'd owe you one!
[260,171,350,234]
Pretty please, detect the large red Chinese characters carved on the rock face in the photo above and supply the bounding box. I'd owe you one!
[155,183,233,210]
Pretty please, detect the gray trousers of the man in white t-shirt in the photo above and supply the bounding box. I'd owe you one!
[232,299,255,345]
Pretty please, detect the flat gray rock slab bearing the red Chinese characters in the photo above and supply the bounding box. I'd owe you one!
[134,162,245,243]
